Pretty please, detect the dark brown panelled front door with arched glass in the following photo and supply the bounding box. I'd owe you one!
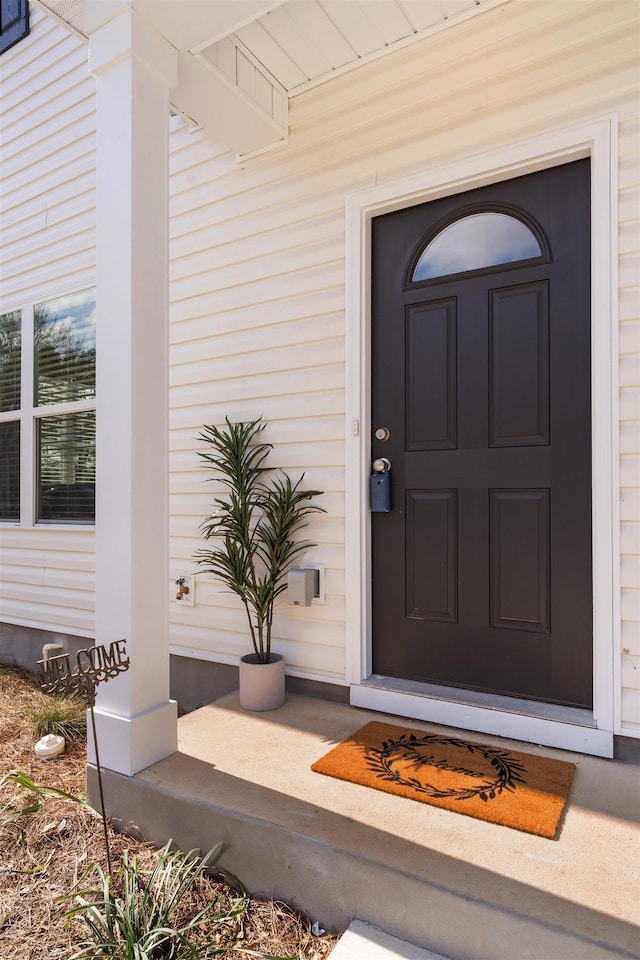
[371,160,592,707]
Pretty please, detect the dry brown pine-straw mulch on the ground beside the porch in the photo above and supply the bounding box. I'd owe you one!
[0,666,337,960]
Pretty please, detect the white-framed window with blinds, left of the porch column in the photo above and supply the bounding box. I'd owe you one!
[0,290,96,525]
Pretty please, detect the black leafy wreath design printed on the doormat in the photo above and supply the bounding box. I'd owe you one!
[366,733,527,803]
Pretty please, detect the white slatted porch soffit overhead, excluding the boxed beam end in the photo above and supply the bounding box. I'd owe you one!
[36,0,508,97]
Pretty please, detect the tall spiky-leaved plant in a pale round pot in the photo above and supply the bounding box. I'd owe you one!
[195,417,323,710]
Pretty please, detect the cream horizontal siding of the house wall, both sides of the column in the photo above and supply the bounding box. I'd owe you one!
[0,0,640,736]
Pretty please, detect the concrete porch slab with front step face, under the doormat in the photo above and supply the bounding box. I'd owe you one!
[89,694,640,960]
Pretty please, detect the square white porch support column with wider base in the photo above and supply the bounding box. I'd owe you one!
[85,0,177,776]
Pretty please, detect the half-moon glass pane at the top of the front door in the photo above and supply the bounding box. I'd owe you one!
[411,213,542,283]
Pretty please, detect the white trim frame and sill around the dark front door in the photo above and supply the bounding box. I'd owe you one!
[345,115,621,756]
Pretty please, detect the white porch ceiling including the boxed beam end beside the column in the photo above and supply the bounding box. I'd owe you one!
[36,0,508,154]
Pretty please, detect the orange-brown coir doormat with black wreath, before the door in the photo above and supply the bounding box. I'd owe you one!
[311,721,575,839]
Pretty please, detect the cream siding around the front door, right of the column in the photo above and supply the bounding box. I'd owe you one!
[170,0,640,720]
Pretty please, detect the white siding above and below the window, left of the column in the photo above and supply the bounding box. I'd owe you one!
[0,5,95,637]
